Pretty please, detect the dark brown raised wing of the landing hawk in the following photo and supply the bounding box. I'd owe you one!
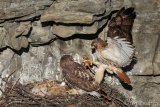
[107,7,136,44]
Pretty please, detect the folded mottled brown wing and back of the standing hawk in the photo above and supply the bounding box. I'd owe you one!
[62,62,100,92]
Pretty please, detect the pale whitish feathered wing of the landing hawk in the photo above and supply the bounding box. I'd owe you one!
[99,37,135,67]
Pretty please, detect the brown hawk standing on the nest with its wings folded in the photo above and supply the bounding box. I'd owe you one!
[60,55,110,99]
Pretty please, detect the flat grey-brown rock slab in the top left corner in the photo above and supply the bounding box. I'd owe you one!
[0,0,53,21]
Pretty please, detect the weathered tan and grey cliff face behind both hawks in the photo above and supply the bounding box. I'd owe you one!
[0,0,160,107]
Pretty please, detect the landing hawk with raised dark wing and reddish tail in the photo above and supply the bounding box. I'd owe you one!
[91,7,136,84]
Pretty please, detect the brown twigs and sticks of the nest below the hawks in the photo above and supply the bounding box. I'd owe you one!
[0,79,134,107]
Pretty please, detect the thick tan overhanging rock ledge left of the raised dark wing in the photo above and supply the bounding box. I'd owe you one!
[40,0,110,38]
